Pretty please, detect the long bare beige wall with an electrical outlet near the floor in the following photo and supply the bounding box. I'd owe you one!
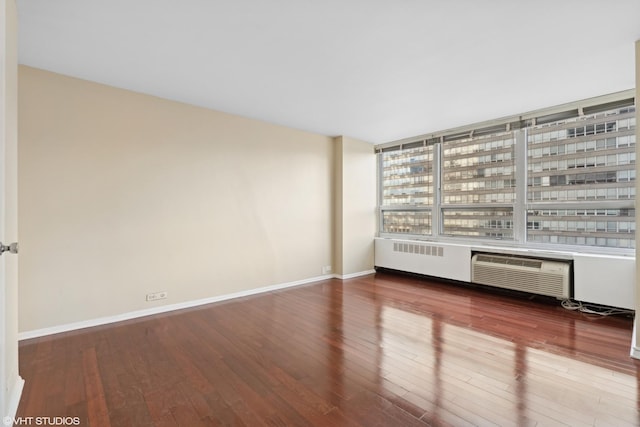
[19,67,342,332]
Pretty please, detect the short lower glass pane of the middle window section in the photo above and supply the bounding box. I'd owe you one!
[442,208,513,240]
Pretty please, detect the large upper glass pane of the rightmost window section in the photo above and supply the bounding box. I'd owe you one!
[527,107,635,202]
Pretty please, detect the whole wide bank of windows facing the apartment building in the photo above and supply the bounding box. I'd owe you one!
[378,94,636,250]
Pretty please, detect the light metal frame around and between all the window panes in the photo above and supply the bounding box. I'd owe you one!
[376,90,638,256]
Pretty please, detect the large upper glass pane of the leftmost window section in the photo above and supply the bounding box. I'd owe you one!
[382,146,433,206]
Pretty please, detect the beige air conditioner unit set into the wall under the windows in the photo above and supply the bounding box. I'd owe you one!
[471,253,571,299]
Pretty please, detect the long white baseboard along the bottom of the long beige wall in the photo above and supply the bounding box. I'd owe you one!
[18,274,339,341]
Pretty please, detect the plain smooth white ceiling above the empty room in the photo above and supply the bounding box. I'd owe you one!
[17,0,640,143]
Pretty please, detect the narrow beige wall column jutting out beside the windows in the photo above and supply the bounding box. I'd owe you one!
[334,137,377,276]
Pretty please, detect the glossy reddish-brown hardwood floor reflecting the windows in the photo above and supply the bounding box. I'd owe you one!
[17,273,640,427]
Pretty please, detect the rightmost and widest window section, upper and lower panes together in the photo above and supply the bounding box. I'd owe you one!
[527,108,636,248]
